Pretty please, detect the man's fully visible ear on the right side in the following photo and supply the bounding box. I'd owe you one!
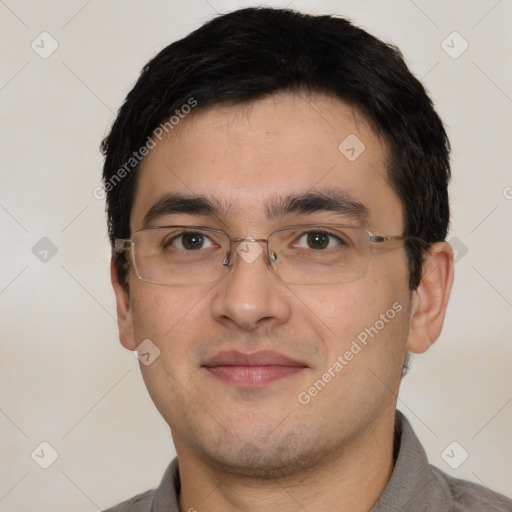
[407,242,453,354]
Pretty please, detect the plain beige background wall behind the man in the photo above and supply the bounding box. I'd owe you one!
[0,0,512,512]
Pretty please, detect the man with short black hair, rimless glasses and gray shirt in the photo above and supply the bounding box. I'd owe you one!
[102,5,512,512]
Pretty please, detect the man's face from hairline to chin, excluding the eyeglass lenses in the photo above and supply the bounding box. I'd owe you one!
[117,94,420,477]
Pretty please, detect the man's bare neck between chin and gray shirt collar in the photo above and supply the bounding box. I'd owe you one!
[175,412,394,512]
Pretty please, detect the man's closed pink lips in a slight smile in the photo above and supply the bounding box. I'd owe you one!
[203,351,308,388]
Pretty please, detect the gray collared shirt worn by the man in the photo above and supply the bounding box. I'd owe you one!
[105,411,512,512]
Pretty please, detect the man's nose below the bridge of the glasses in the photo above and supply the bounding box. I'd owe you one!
[212,240,291,331]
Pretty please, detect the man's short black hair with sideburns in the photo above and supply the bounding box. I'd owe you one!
[101,8,450,290]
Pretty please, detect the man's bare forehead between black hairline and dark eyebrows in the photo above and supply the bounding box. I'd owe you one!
[131,94,402,232]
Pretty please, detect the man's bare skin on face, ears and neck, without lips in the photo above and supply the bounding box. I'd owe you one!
[112,94,453,512]
